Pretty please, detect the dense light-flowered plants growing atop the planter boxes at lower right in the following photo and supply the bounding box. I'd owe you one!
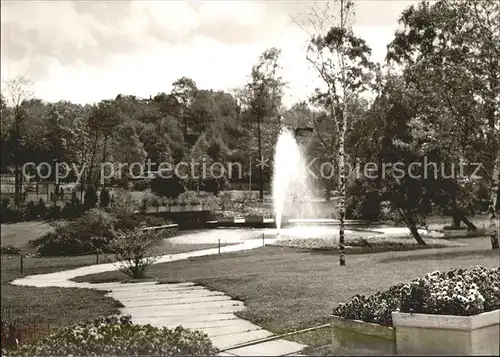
[333,266,500,326]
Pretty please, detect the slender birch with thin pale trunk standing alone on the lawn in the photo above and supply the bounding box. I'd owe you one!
[294,0,375,266]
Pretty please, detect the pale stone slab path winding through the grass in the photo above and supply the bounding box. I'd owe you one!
[12,240,306,356]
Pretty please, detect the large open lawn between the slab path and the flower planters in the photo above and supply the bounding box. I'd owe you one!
[75,237,499,345]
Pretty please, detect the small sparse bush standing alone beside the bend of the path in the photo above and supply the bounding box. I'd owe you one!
[107,227,162,279]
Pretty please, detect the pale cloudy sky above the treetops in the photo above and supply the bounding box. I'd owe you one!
[1,0,417,106]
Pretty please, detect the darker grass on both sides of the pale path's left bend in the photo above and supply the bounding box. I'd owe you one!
[1,244,232,326]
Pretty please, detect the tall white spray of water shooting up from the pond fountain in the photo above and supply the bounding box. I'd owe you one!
[272,129,315,234]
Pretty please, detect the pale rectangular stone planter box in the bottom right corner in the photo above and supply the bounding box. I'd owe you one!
[392,310,500,356]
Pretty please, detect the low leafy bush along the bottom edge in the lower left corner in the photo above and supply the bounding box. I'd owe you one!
[2,316,218,356]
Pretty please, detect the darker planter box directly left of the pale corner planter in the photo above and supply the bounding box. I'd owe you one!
[330,315,396,356]
